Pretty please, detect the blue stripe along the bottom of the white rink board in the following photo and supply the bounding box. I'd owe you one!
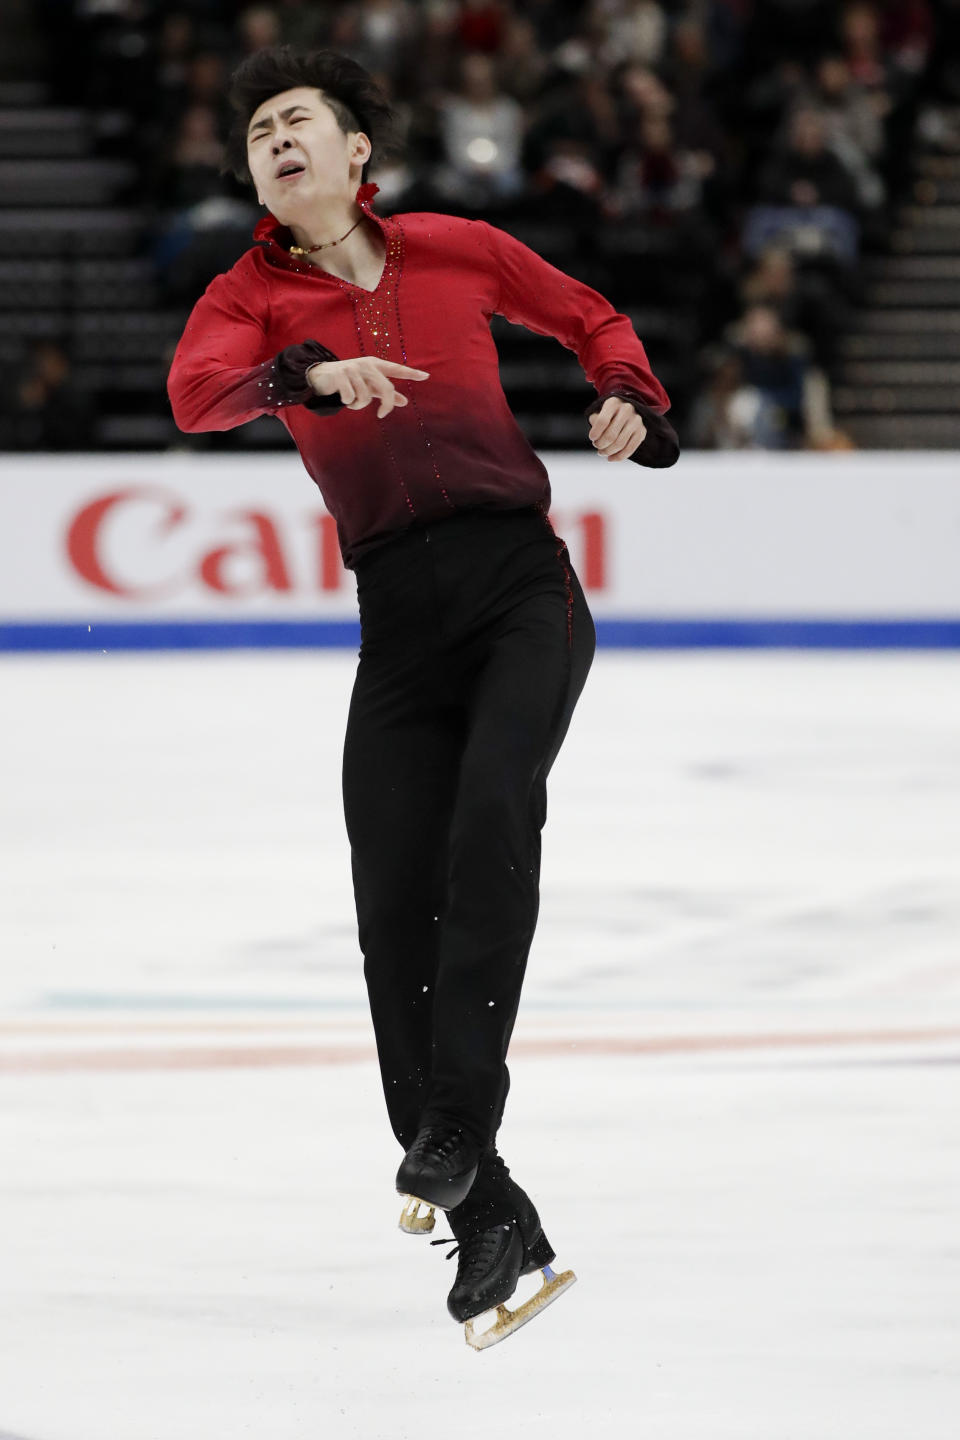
[0,618,960,654]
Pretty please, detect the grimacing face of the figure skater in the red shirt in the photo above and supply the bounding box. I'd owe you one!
[246,85,371,225]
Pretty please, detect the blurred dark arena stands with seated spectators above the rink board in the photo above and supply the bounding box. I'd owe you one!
[0,0,960,449]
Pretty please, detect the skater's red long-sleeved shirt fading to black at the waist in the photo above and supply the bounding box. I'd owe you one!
[167,183,676,567]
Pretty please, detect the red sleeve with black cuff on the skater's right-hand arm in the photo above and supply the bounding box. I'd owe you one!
[479,220,679,468]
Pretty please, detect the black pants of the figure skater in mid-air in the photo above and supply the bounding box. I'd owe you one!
[343,507,596,1149]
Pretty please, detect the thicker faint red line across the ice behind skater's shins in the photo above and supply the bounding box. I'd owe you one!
[0,1027,960,1074]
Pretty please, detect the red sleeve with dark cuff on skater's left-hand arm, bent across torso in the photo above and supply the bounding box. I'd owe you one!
[167,266,343,432]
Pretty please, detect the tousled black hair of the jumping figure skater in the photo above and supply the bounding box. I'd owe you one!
[220,45,402,184]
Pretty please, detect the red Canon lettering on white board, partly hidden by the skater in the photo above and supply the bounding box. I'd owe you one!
[66,484,606,603]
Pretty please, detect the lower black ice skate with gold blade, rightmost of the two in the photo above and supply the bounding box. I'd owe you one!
[430,1152,576,1349]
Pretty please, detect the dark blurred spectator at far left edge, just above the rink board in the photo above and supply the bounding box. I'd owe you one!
[0,340,94,451]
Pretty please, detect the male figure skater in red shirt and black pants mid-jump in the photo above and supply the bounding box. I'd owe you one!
[168,46,678,1348]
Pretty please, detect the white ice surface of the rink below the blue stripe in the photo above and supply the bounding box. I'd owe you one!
[0,651,960,1440]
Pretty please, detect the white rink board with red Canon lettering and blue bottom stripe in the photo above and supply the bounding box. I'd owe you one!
[0,452,960,652]
